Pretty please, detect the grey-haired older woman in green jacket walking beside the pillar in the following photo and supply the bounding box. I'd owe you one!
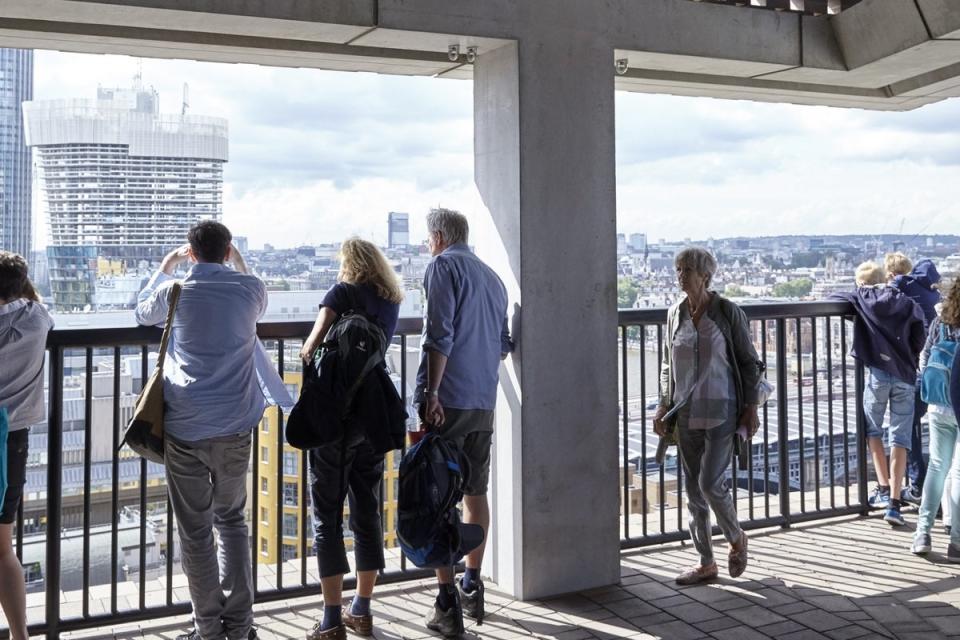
[654,247,762,584]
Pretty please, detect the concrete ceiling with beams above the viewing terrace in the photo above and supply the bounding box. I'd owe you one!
[0,0,960,110]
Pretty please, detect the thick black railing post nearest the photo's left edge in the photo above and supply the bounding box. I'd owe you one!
[43,346,63,640]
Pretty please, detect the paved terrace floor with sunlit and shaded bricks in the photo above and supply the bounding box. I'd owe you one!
[63,514,960,640]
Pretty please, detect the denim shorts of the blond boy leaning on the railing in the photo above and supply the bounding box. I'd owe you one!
[863,367,916,451]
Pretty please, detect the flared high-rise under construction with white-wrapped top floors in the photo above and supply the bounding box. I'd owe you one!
[24,86,227,310]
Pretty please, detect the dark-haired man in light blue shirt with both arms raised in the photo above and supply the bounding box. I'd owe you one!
[136,220,292,640]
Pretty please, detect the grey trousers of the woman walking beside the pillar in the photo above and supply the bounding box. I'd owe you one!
[678,415,743,565]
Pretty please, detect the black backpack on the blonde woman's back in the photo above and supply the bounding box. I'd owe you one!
[285,288,387,450]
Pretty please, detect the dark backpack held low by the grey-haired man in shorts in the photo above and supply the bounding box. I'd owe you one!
[397,433,483,569]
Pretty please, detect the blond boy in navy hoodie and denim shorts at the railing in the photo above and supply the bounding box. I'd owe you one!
[831,262,926,526]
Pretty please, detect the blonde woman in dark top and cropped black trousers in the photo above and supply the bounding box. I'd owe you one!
[300,238,403,640]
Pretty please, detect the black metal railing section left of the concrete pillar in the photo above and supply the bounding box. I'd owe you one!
[13,318,432,638]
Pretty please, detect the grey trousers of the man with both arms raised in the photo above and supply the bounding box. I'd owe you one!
[165,433,253,640]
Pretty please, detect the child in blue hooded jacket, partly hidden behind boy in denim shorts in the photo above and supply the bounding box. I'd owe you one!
[884,252,940,505]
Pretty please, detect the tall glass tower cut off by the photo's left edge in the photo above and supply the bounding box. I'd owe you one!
[0,49,33,259]
